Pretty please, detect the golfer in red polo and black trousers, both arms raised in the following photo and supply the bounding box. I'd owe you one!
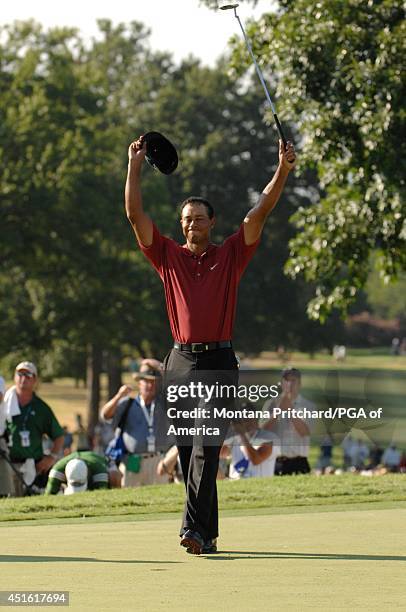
[125,136,296,554]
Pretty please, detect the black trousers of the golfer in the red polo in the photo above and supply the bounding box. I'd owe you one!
[164,348,238,540]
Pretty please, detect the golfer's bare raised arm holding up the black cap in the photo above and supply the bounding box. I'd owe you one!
[125,136,153,247]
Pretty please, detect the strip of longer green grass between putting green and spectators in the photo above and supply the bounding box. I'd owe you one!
[0,474,406,521]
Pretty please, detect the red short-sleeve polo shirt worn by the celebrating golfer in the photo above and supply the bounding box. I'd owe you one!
[140,225,259,344]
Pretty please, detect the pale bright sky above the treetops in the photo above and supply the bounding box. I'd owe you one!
[0,0,272,66]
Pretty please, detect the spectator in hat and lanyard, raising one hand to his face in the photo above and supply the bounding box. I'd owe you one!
[101,359,173,487]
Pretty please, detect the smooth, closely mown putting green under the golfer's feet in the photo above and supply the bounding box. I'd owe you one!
[0,509,406,612]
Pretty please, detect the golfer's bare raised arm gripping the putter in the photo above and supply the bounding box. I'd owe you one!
[244,140,296,245]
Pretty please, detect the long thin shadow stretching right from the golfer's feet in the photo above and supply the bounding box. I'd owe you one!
[206,550,406,561]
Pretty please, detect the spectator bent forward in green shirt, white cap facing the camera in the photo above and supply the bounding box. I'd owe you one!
[45,451,121,495]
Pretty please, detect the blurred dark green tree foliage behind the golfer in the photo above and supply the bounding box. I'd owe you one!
[0,20,344,392]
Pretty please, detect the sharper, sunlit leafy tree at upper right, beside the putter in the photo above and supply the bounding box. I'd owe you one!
[206,0,406,320]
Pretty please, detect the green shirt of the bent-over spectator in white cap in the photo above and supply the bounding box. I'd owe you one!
[45,451,109,495]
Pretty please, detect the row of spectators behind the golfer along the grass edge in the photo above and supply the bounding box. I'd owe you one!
[0,359,406,497]
